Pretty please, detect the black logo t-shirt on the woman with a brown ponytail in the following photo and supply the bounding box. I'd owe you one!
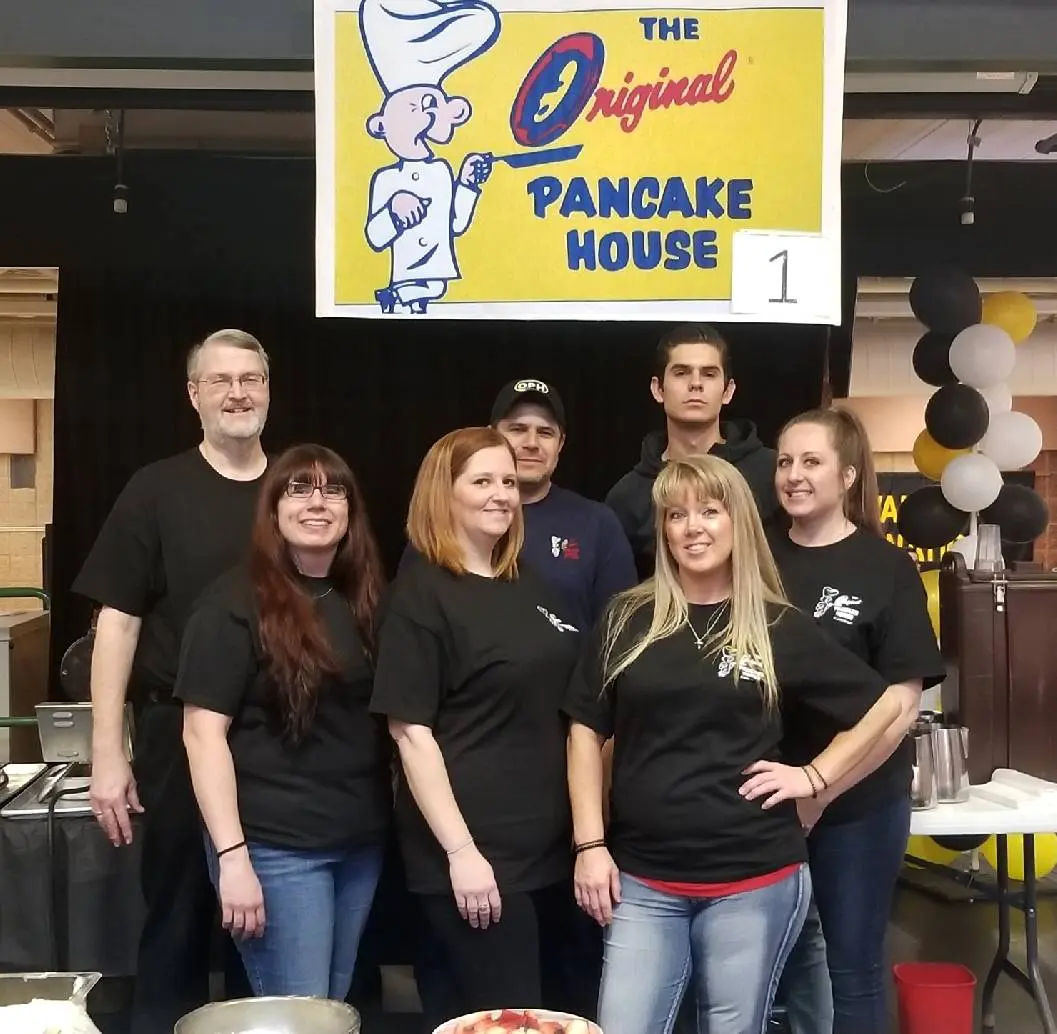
[768,528,944,824]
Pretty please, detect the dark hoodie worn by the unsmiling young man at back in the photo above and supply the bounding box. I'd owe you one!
[606,420,779,578]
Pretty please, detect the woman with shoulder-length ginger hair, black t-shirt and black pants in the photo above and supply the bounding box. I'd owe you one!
[371,427,590,1026]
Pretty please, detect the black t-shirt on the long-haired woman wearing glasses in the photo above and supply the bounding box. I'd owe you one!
[174,569,392,850]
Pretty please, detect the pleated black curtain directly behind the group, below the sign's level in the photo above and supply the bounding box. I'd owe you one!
[52,260,827,659]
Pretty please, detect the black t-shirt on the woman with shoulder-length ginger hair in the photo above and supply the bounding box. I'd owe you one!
[371,557,580,893]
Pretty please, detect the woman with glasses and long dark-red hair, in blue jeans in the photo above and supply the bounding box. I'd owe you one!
[175,445,391,999]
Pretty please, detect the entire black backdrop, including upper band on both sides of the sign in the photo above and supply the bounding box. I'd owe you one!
[0,154,1057,676]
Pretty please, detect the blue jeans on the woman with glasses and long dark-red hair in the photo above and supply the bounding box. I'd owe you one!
[206,838,383,1001]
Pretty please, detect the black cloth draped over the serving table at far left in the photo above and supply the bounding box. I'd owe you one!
[0,816,144,977]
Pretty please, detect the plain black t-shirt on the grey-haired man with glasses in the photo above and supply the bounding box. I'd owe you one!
[73,447,261,694]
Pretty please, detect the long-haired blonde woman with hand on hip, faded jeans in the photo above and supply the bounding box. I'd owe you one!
[564,456,898,1034]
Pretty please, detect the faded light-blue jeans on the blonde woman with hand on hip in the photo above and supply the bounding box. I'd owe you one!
[598,865,811,1034]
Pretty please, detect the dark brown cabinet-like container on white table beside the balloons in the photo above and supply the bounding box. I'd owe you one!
[940,554,1057,782]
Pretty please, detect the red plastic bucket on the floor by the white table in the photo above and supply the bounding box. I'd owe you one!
[892,962,977,1034]
